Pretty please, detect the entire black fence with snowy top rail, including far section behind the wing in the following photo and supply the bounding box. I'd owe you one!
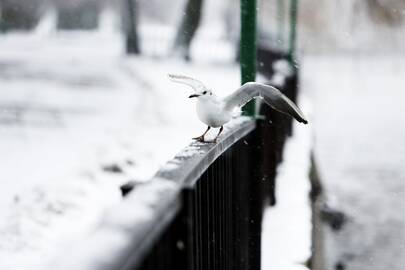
[53,48,297,270]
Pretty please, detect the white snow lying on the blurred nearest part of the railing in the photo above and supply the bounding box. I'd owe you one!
[43,178,180,270]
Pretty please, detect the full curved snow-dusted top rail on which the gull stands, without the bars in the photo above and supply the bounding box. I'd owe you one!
[52,117,255,270]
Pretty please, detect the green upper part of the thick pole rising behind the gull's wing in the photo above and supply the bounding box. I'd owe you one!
[240,0,256,116]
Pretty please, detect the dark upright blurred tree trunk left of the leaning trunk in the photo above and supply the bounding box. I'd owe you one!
[122,0,140,54]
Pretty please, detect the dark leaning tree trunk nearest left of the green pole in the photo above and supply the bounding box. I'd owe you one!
[173,0,203,61]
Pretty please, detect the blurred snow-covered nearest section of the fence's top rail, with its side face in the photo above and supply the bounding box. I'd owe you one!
[51,179,181,270]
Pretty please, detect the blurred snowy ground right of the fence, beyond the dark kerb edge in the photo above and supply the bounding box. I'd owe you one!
[302,55,405,270]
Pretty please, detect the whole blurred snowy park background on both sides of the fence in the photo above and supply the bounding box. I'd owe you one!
[0,0,405,270]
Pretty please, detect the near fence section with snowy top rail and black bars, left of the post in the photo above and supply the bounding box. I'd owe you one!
[52,118,260,270]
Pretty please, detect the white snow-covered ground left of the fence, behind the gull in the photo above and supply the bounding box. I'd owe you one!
[0,18,240,270]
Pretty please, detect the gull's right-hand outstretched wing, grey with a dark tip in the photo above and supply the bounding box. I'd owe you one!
[224,82,308,124]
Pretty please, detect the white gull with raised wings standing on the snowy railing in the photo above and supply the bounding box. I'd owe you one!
[169,74,308,142]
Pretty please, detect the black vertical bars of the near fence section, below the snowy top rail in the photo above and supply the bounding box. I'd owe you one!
[139,124,263,270]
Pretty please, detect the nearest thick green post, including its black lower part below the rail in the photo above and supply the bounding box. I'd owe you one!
[240,0,263,270]
